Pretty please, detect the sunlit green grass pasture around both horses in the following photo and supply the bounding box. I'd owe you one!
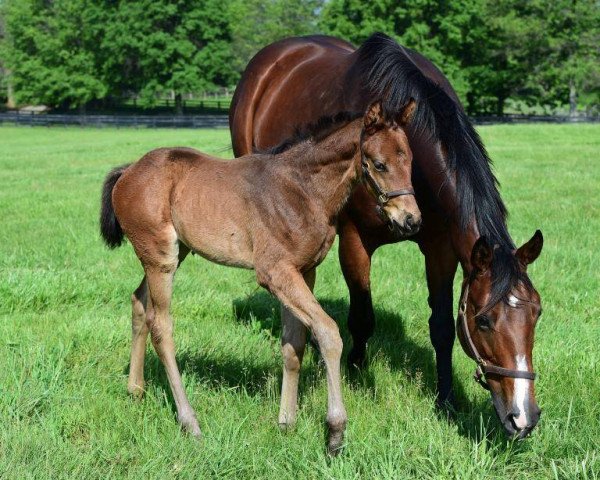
[0,125,600,479]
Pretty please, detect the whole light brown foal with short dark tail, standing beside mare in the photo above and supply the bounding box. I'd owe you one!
[101,102,421,454]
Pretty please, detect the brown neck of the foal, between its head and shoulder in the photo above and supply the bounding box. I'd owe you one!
[292,118,363,220]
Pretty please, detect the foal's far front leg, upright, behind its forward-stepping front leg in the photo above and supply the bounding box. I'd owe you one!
[279,269,315,429]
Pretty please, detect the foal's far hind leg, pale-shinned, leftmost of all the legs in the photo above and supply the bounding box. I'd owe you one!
[127,244,189,397]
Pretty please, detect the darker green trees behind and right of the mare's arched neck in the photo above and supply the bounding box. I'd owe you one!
[320,0,600,114]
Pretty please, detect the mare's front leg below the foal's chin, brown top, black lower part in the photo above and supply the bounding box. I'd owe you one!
[338,219,375,367]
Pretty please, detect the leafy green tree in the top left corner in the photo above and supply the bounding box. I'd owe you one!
[3,0,107,107]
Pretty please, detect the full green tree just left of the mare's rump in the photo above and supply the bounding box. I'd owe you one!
[101,0,237,113]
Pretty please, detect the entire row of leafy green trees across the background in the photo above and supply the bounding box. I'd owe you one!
[0,0,600,114]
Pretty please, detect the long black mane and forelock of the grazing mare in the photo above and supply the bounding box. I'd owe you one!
[352,33,531,306]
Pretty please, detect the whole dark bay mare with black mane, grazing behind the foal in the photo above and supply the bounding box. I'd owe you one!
[229,34,543,438]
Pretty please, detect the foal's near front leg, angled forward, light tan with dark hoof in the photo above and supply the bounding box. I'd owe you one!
[256,263,348,455]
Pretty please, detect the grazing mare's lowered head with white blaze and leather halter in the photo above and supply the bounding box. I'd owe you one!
[457,230,543,438]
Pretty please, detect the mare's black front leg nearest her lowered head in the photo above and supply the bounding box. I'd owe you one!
[419,235,458,408]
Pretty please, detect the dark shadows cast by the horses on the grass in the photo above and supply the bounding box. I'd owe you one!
[134,291,520,450]
